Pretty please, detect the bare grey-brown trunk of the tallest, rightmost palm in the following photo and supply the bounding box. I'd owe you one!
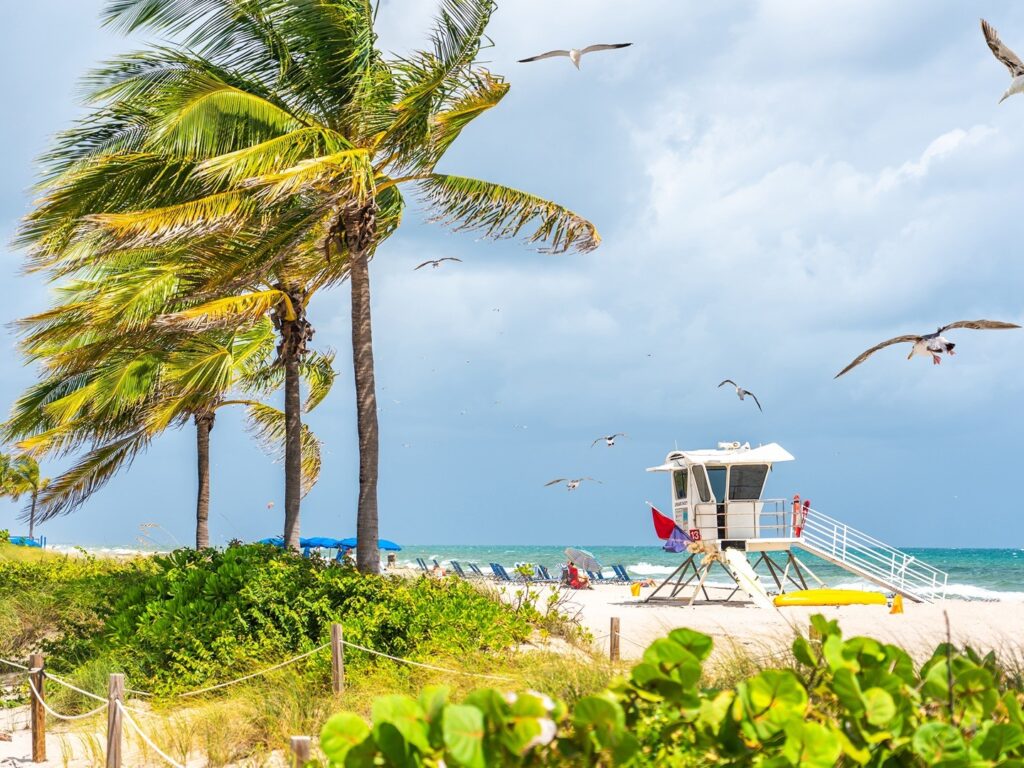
[345,205,381,573]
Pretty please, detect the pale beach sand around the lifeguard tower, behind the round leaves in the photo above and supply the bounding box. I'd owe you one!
[512,585,1024,658]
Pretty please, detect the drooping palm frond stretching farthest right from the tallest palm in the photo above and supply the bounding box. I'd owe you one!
[419,173,601,253]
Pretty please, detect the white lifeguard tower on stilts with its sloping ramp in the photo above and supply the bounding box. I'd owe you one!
[647,442,948,607]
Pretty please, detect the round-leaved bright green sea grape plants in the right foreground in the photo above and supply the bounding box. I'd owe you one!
[321,616,1024,768]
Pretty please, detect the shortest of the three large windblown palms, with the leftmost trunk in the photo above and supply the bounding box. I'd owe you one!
[2,288,334,549]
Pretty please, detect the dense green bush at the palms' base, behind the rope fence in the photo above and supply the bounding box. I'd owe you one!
[41,546,531,693]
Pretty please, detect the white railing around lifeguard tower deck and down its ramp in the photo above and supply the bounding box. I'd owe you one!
[694,499,949,602]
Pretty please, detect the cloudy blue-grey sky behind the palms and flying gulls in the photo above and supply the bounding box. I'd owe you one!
[0,0,1024,548]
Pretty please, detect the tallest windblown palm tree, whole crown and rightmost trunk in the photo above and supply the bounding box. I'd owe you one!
[28,0,600,571]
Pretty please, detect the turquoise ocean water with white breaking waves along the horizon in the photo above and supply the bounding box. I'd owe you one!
[387,544,1024,602]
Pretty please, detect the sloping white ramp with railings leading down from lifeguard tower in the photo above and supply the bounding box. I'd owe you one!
[794,509,949,603]
